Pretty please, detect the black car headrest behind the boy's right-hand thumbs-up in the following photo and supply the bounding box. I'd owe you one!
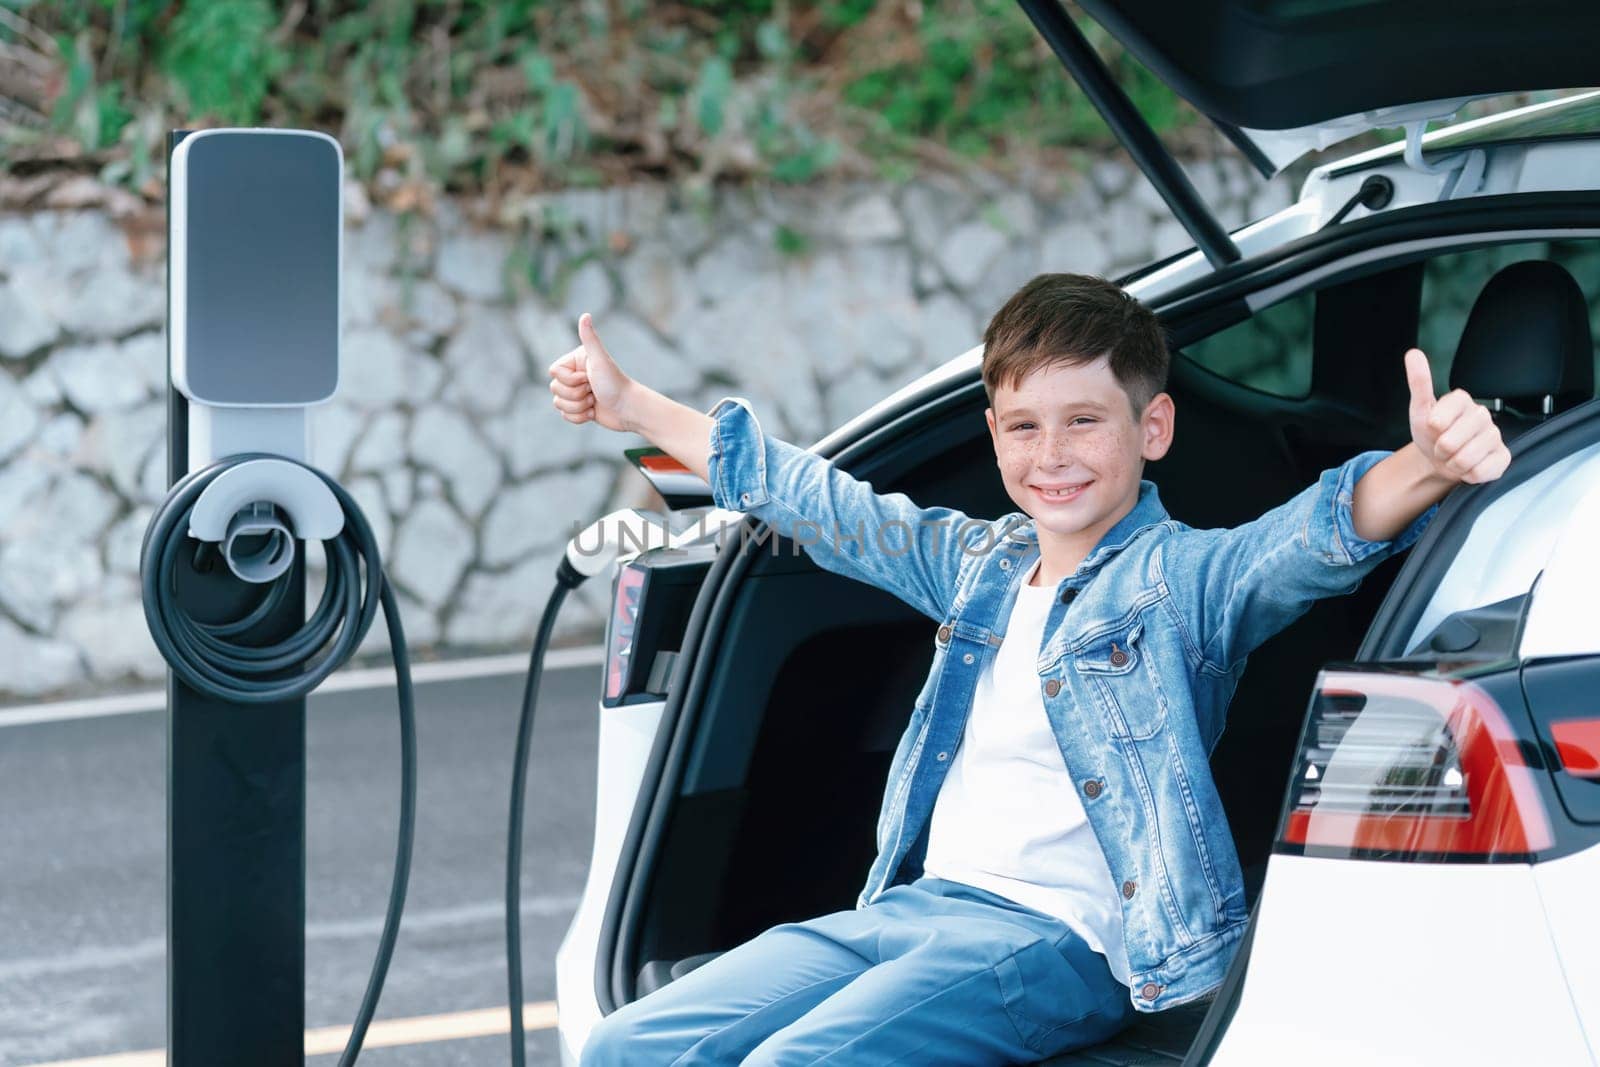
[1450,259,1595,416]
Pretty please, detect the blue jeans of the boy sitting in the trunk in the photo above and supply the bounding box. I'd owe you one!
[581,875,1136,1067]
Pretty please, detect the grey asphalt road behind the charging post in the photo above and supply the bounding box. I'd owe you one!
[0,665,600,1067]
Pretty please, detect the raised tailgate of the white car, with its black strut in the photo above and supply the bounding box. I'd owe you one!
[1019,0,1600,270]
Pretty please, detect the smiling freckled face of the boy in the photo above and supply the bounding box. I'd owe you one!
[984,355,1173,566]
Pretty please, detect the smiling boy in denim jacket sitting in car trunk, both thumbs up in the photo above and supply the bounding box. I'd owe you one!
[550,274,1510,1064]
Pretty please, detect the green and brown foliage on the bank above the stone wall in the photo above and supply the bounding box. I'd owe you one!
[0,0,1195,202]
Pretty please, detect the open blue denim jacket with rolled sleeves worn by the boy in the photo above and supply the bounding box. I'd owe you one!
[707,397,1437,1011]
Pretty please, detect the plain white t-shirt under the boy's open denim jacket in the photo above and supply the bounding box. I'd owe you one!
[923,556,1128,984]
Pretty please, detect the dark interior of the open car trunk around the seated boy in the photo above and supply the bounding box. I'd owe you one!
[619,360,1403,1064]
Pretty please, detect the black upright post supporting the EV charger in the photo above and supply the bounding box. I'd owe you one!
[166,131,306,1067]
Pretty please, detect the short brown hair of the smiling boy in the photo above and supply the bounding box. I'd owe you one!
[982,274,1170,418]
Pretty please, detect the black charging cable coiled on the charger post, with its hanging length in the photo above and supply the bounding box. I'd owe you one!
[139,453,416,1067]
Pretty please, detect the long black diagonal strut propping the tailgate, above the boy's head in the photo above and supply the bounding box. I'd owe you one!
[1018,0,1238,267]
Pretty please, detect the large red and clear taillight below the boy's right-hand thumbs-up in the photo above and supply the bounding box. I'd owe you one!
[1282,670,1554,861]
